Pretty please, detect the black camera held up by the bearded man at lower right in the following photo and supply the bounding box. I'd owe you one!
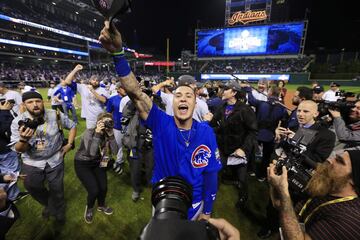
[275,128,317,194]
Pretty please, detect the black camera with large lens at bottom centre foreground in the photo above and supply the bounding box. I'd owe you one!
[139,177,220,240]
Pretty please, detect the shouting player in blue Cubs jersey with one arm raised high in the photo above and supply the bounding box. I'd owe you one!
[99,21,221,220]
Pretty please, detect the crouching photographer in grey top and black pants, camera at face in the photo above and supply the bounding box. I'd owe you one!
[74,113,118,224]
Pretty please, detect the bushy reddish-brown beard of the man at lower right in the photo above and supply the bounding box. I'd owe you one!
[307,162,351,197]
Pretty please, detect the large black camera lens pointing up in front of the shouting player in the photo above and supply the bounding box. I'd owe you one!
[151,177,192,219]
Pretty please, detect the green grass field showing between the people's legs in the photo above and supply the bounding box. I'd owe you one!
[7,85,360,240]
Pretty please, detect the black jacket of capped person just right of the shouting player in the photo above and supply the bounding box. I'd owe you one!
[210,101,257,157]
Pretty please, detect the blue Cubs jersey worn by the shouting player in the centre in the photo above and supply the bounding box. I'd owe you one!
[145,104,221,216]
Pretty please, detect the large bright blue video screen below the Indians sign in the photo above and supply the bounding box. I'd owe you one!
[197,22,304,58]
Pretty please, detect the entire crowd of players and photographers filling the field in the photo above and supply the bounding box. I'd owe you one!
[0,23,360,239]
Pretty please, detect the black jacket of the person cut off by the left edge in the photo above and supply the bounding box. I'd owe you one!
[0,110,14,154]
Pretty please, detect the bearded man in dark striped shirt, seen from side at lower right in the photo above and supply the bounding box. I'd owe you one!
[268,149,360,240]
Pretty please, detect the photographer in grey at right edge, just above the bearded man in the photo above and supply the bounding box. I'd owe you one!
[329,100,360,147]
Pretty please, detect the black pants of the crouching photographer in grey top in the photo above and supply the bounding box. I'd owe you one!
[74,160,107,208]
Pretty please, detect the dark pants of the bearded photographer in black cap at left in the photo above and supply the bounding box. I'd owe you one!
[22,163,65,219]
